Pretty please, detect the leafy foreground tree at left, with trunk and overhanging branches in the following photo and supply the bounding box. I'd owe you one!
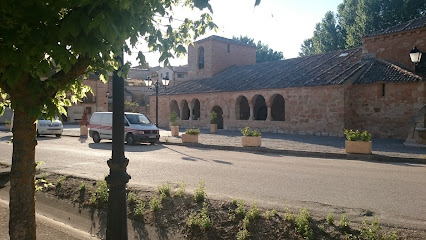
[0,0,260,240]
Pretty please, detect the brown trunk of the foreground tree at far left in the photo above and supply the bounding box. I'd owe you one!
[9,110,37,240]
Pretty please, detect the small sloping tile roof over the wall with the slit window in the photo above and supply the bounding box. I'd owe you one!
[354,60,423,84]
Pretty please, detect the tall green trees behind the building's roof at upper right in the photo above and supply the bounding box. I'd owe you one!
[299,0,426,56]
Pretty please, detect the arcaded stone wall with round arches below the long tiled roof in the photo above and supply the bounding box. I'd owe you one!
[150,86,345,136]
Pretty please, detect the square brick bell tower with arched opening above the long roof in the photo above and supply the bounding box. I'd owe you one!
[188,35,256,79]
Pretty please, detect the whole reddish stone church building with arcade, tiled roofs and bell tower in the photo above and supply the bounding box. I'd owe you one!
[150,17,426,139]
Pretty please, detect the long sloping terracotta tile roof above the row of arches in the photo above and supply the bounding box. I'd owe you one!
[163,48,362,94]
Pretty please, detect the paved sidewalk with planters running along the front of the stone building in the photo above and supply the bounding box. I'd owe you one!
[63,125,426,164]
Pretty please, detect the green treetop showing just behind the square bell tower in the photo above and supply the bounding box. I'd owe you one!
[232,36,284,63]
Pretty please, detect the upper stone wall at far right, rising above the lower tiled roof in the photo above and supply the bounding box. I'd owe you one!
[362,28,426,70]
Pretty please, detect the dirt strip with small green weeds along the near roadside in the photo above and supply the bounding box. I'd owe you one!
[32,172,426,239]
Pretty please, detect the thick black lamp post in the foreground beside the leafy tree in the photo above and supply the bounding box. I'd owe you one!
[105,52,130,240]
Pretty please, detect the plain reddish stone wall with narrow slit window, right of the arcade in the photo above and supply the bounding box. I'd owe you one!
[345,82,426,139]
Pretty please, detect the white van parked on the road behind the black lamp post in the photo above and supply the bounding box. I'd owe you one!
[89,112,160,144]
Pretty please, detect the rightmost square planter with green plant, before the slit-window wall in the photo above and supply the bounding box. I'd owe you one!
[344,129,373,154]
